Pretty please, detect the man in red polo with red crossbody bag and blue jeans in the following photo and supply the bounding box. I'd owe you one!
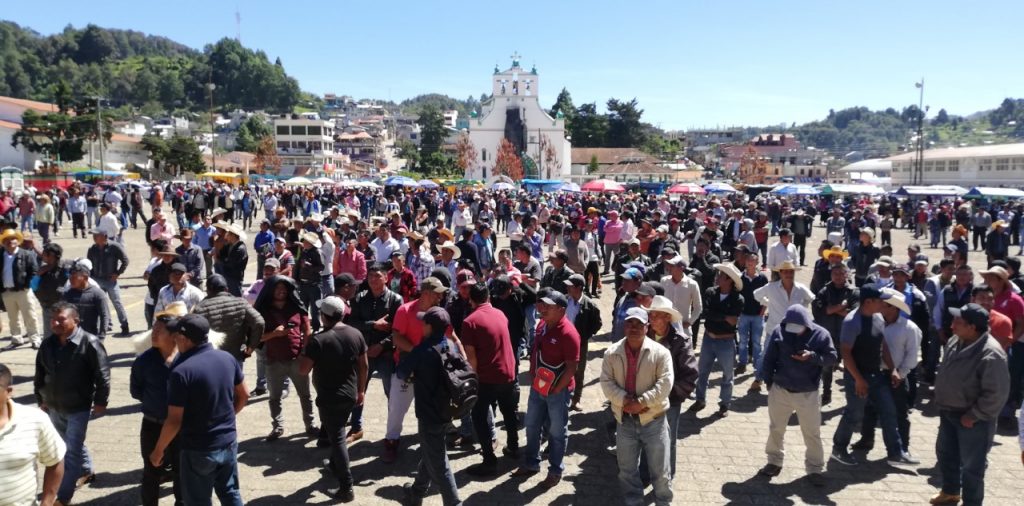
[512,290,580,489]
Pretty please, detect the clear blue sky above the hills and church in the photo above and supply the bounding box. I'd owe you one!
[0,0,1024,129]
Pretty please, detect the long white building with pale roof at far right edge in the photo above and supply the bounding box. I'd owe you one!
[886,143,1024,188]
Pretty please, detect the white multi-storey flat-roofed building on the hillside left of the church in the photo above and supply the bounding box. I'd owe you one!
[273,113,337,176]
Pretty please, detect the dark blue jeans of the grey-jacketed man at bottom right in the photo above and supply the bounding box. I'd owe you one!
[935,411,995,506]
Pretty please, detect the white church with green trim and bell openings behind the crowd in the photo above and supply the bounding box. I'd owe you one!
[466,53,571,182]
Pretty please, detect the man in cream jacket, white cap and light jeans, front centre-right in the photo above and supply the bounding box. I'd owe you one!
[601,307,675,506]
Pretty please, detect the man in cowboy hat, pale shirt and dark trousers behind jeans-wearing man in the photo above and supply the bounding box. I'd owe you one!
[852,288,922,455]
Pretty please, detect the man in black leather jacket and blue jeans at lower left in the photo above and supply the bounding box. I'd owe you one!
[33,302,111,504]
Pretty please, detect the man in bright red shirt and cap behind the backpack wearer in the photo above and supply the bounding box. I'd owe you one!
[382,277,447,464]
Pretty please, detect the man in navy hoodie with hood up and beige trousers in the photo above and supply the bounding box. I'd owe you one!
[758,304,837,487]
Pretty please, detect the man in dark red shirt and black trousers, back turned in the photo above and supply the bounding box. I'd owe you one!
[461,283,519,476]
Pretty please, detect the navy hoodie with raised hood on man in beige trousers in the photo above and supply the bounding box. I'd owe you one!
[761,304,837,392]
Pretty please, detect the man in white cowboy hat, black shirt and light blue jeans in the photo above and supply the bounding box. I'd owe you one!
[690,263,743,417]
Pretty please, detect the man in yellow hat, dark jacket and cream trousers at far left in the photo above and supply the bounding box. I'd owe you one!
[0,228,43,349]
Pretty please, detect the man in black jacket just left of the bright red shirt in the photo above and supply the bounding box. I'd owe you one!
[345,264,401,444]
